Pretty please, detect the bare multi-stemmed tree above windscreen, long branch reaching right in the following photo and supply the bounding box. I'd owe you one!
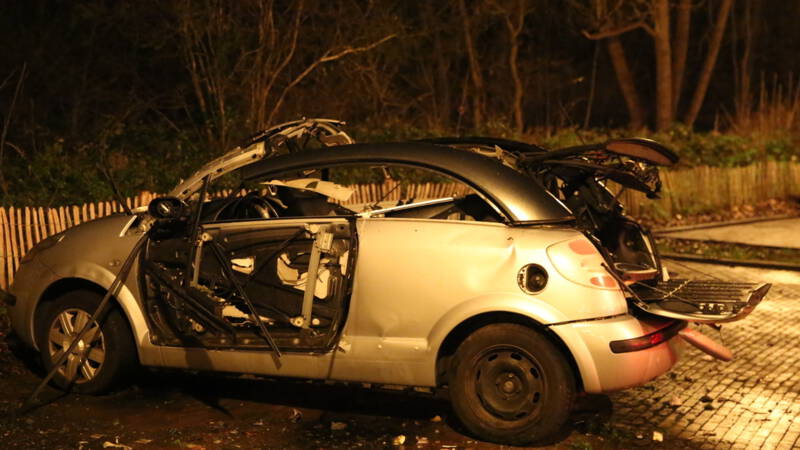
[175,0,396,148]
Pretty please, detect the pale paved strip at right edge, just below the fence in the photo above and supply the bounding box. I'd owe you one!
[664,218,800,248]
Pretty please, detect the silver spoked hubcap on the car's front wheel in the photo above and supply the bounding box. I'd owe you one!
[48,308,106,383]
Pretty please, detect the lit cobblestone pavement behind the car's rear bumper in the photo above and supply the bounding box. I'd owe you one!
[611,261,800,449]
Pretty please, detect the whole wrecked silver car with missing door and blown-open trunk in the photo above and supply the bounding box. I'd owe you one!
[4,119,769,444]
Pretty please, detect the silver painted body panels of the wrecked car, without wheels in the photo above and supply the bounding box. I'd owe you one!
[10,119,679,392]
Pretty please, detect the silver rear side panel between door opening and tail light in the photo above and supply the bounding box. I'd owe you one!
[331,218,627,386]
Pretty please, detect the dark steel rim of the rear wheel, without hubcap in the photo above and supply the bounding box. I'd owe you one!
[473,348,546,421]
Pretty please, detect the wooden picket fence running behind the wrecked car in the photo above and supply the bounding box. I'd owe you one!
[0,162,800,289]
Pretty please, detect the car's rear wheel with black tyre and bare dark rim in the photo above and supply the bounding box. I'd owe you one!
[449,323,575,445]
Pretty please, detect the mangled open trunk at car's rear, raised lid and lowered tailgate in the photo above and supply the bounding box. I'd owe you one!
[427,137,771,324]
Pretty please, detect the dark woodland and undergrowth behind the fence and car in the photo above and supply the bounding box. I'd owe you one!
[0,0,800,206]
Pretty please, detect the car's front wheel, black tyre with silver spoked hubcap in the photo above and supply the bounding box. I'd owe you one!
[36,290,138,394]
